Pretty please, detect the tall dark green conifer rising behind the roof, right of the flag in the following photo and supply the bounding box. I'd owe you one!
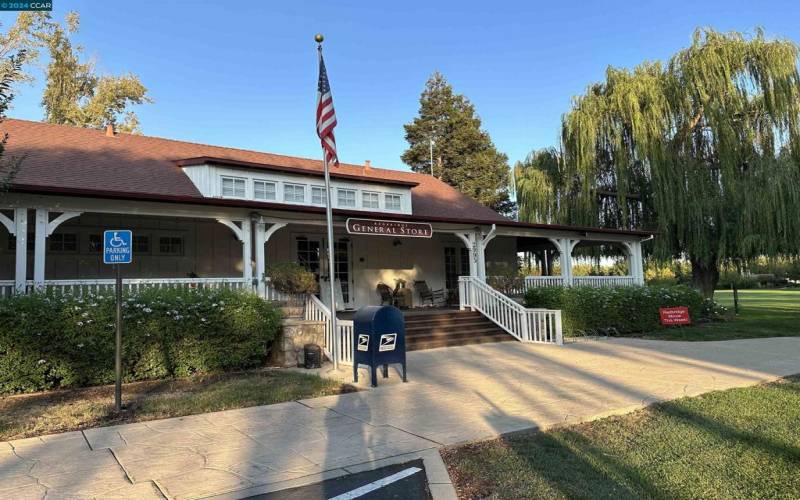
[402,72,514,213]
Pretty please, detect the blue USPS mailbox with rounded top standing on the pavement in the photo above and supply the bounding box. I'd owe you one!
[353,306,407,387]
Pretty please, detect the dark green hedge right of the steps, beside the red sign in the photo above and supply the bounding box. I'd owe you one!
[525,285,708,335]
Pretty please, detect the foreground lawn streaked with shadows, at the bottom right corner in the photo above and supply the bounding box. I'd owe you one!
[442,376,800,500]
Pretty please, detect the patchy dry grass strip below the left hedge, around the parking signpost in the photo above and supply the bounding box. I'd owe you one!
[0,370,355,441]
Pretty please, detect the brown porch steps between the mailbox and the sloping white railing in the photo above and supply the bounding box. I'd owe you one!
[405,311,514,351]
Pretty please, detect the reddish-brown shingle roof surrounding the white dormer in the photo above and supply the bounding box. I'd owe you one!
[0,118,508,222]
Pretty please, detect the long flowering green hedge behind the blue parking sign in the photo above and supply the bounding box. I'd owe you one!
[0,289,281,393]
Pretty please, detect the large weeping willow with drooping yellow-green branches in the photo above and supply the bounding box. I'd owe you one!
[560,29,800,296]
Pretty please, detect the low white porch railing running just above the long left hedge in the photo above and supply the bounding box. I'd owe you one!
[0,278,251,297]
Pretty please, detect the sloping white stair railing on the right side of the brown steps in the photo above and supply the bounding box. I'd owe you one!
[458,276,564,345]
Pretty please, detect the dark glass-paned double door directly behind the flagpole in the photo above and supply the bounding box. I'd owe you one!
[295,235,355,309]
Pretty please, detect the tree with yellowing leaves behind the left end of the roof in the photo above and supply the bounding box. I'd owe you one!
[42,14,152,133]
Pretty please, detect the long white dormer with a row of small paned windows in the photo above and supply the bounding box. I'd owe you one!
[175,157,417,214]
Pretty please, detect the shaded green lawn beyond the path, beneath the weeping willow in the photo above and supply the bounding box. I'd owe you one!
[643,289,800,340]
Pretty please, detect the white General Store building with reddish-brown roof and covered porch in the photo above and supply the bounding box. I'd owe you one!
[0,120,651,309]
